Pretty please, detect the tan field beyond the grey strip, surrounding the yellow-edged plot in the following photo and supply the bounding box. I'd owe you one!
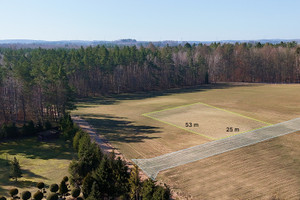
[73,84,300,158]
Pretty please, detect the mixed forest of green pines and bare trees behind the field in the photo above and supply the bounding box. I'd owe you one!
[0,42,300,125]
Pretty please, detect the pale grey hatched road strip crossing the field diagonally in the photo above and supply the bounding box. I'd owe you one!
[132,118,300,179]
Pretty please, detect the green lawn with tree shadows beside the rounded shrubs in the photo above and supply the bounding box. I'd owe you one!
[0,137,76,196]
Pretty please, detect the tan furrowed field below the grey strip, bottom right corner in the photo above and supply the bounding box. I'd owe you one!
[158,132,300,199]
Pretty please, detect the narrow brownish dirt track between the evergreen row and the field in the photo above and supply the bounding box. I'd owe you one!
[72,116,148,180]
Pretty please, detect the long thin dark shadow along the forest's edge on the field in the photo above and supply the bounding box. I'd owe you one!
[77,83,259,108]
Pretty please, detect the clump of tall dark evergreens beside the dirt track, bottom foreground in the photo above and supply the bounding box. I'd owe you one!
[69,126,170,200]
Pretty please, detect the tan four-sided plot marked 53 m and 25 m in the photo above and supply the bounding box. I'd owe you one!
[143,103,271,140]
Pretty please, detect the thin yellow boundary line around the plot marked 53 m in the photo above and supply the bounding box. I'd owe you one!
[142,102,274,140]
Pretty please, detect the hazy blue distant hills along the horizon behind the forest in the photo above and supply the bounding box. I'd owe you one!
[0,39,300,48]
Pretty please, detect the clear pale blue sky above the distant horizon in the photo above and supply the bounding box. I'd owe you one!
[0,0,300,41]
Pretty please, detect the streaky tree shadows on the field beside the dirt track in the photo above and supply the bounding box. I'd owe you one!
[80,114,160,143]
